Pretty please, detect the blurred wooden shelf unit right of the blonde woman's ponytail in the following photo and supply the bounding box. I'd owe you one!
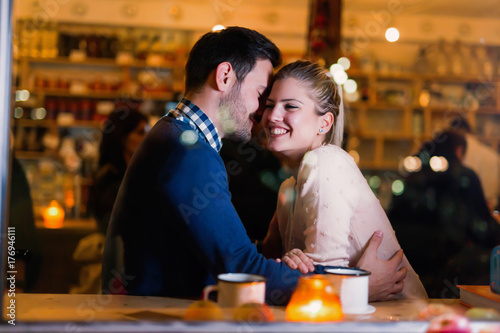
[347,70,500,171]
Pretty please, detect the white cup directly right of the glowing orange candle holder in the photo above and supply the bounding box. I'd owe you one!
[325,267,375,314]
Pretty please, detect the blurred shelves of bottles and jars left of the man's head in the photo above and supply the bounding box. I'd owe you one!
[12,24,189,219]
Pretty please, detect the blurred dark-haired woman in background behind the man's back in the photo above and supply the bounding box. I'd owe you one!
[91,108,148,234]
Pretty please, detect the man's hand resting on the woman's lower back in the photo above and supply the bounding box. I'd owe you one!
[357,231,407,302]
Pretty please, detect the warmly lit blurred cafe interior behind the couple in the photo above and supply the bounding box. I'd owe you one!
[3,0,500,293]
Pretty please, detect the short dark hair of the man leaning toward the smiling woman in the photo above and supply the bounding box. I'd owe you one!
[186,27,281,93]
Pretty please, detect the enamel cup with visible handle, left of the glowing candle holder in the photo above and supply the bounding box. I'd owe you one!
[203,273,267,308]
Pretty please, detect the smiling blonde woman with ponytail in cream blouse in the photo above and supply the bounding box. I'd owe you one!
[262,61,427,298]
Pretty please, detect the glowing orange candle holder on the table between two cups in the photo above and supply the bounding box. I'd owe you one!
[286,274,344,322]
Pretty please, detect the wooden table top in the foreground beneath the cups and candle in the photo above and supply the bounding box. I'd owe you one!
[0,294,491,333]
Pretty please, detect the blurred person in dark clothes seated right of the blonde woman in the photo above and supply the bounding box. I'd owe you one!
[388,131,500,298]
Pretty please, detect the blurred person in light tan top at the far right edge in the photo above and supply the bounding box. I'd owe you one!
[450,116,500,211]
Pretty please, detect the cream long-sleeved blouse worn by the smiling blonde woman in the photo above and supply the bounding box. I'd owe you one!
[277,145,427,298]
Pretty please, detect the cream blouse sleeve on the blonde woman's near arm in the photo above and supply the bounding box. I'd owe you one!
[295,148,359,266]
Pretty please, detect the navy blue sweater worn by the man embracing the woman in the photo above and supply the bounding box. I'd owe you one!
[103,117,323,304]
